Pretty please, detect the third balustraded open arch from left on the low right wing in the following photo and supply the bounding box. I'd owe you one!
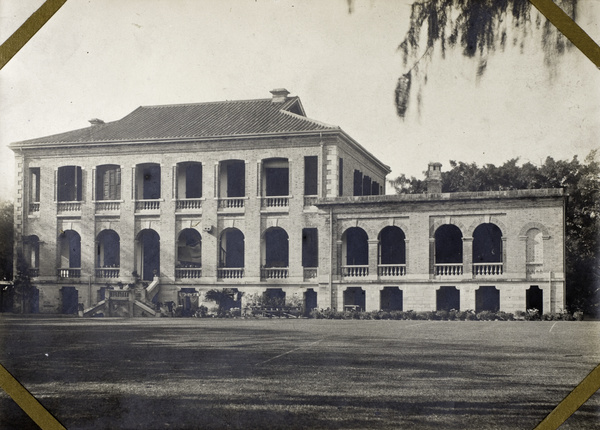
[434,224,463,275]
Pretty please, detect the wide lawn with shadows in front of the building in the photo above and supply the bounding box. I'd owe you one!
[0,315,600,429]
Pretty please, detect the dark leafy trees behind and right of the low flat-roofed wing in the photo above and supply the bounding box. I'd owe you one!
[390,151,600,314]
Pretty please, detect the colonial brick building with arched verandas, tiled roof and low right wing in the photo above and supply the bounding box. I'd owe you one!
[11,89,565,315]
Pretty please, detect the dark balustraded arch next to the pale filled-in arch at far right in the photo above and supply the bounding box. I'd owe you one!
[473,223,503,275]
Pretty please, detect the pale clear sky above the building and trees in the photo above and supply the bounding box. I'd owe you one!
[0,0,600,199]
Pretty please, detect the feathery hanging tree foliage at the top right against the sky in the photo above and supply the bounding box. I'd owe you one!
[392,0,577,118]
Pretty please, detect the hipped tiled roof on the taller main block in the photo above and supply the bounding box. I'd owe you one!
[15,97,339,146]
